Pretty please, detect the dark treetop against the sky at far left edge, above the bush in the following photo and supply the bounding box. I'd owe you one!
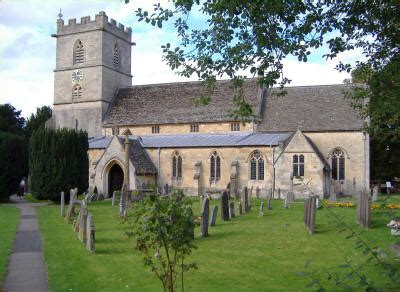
[0,103,25,136]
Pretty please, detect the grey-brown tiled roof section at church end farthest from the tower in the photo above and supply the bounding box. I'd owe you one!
[257,84,363,132]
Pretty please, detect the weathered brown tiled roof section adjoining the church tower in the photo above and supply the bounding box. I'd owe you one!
[103,79,258,126]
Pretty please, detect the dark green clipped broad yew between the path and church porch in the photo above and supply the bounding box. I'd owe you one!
[29,128,89,201]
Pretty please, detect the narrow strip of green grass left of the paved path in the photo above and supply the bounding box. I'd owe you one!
[0,205,20,287]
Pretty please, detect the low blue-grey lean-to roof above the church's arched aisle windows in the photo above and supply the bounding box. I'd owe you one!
[89,133,292,152]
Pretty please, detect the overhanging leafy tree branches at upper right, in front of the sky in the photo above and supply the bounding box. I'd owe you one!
[132,0,400,141]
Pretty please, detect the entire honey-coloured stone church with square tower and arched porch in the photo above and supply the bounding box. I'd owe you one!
[51,12,369,197]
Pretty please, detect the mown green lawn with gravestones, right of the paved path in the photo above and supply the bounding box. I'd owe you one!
[38,195,399,291]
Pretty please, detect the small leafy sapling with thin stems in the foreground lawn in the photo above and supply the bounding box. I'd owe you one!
[128,192,196,291]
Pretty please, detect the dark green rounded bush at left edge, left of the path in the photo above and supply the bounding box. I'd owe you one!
[0,131,28,202]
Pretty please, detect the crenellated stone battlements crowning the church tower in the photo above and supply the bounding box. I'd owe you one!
[57,11,132,42]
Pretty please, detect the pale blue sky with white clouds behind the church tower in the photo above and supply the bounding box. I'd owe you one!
[0,0,361,117]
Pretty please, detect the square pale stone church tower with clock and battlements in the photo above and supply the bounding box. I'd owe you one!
[52,11,132,137]
